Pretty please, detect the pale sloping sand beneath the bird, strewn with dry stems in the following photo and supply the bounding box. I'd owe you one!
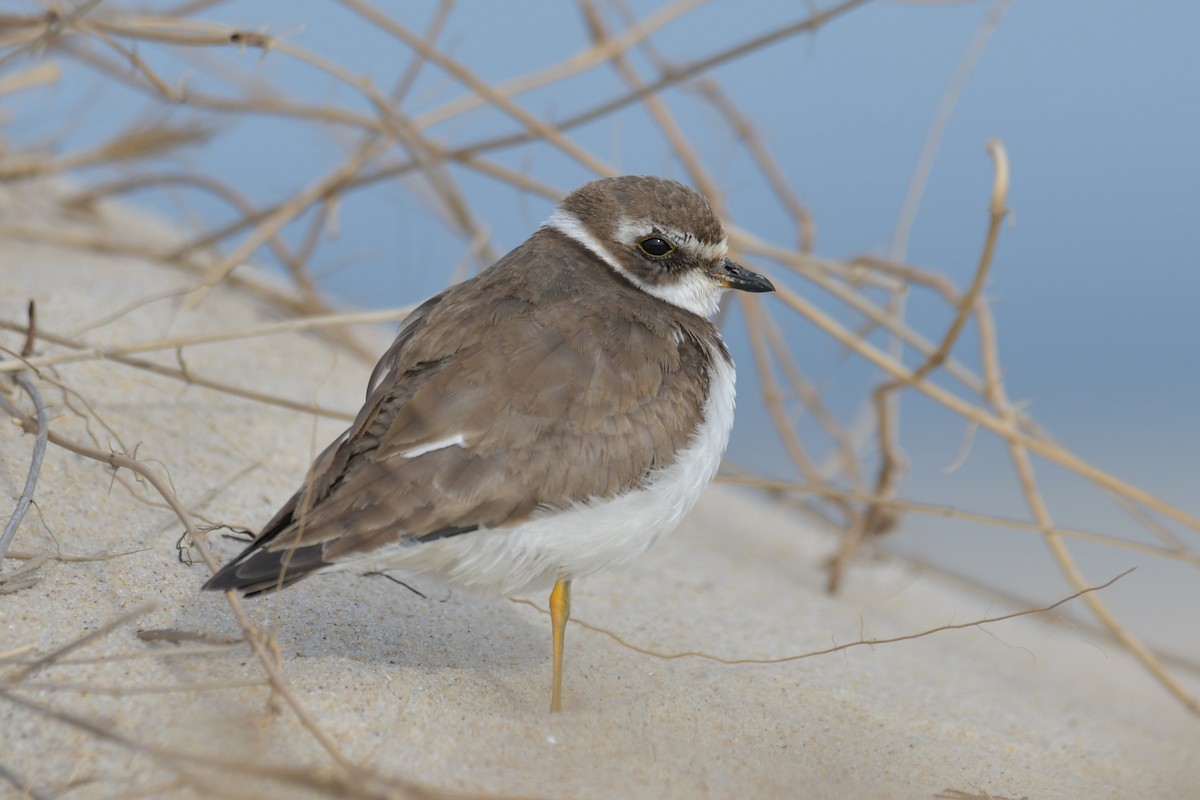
[0,194,1200,800]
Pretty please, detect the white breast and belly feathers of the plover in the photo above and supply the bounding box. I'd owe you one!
[348,353,734,596]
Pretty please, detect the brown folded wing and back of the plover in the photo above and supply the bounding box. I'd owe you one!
[205,244,719,593]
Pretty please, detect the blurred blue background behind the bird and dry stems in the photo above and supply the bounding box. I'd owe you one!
[0,0,1200,681]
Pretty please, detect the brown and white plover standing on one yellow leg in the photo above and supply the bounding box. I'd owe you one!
[204,175,775,711]
